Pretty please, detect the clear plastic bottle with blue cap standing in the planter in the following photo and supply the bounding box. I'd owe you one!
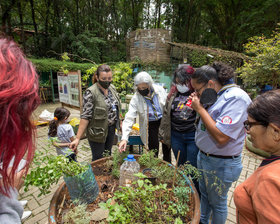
[119,155,140,187]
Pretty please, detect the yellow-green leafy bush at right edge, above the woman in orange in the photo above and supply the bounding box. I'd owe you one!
[238,24,280,88]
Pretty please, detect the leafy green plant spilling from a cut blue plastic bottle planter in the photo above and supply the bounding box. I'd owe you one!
[24,145,99,204]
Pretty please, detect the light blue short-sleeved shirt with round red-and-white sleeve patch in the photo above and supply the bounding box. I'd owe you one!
[195,87,251,156]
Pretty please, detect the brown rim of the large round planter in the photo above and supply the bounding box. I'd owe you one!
[48,155,200,224]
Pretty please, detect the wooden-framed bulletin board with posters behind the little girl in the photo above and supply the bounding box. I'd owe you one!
[57,70,82,110]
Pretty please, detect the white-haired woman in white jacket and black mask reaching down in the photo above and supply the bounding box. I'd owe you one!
[119,72,171,162]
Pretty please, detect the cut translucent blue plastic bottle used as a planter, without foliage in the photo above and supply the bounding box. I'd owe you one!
[63,165,99,204]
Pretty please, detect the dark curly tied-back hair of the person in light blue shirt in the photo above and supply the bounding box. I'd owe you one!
[192,62,234,85]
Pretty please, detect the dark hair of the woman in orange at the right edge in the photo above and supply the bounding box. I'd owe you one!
[247,89,280,128]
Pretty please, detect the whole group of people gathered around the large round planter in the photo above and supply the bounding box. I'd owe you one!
[0,38,280,224]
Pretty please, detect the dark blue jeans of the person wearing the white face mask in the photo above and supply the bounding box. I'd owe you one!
[171,130,199,167]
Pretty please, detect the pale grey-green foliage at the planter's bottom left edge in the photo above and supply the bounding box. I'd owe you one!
[63,202,91,224]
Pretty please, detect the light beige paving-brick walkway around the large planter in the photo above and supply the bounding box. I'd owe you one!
[19,103,260,224]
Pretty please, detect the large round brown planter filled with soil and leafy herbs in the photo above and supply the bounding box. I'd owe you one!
[49,150,200,224]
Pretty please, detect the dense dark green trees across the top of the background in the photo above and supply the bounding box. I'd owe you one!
[0,0,280,63]
